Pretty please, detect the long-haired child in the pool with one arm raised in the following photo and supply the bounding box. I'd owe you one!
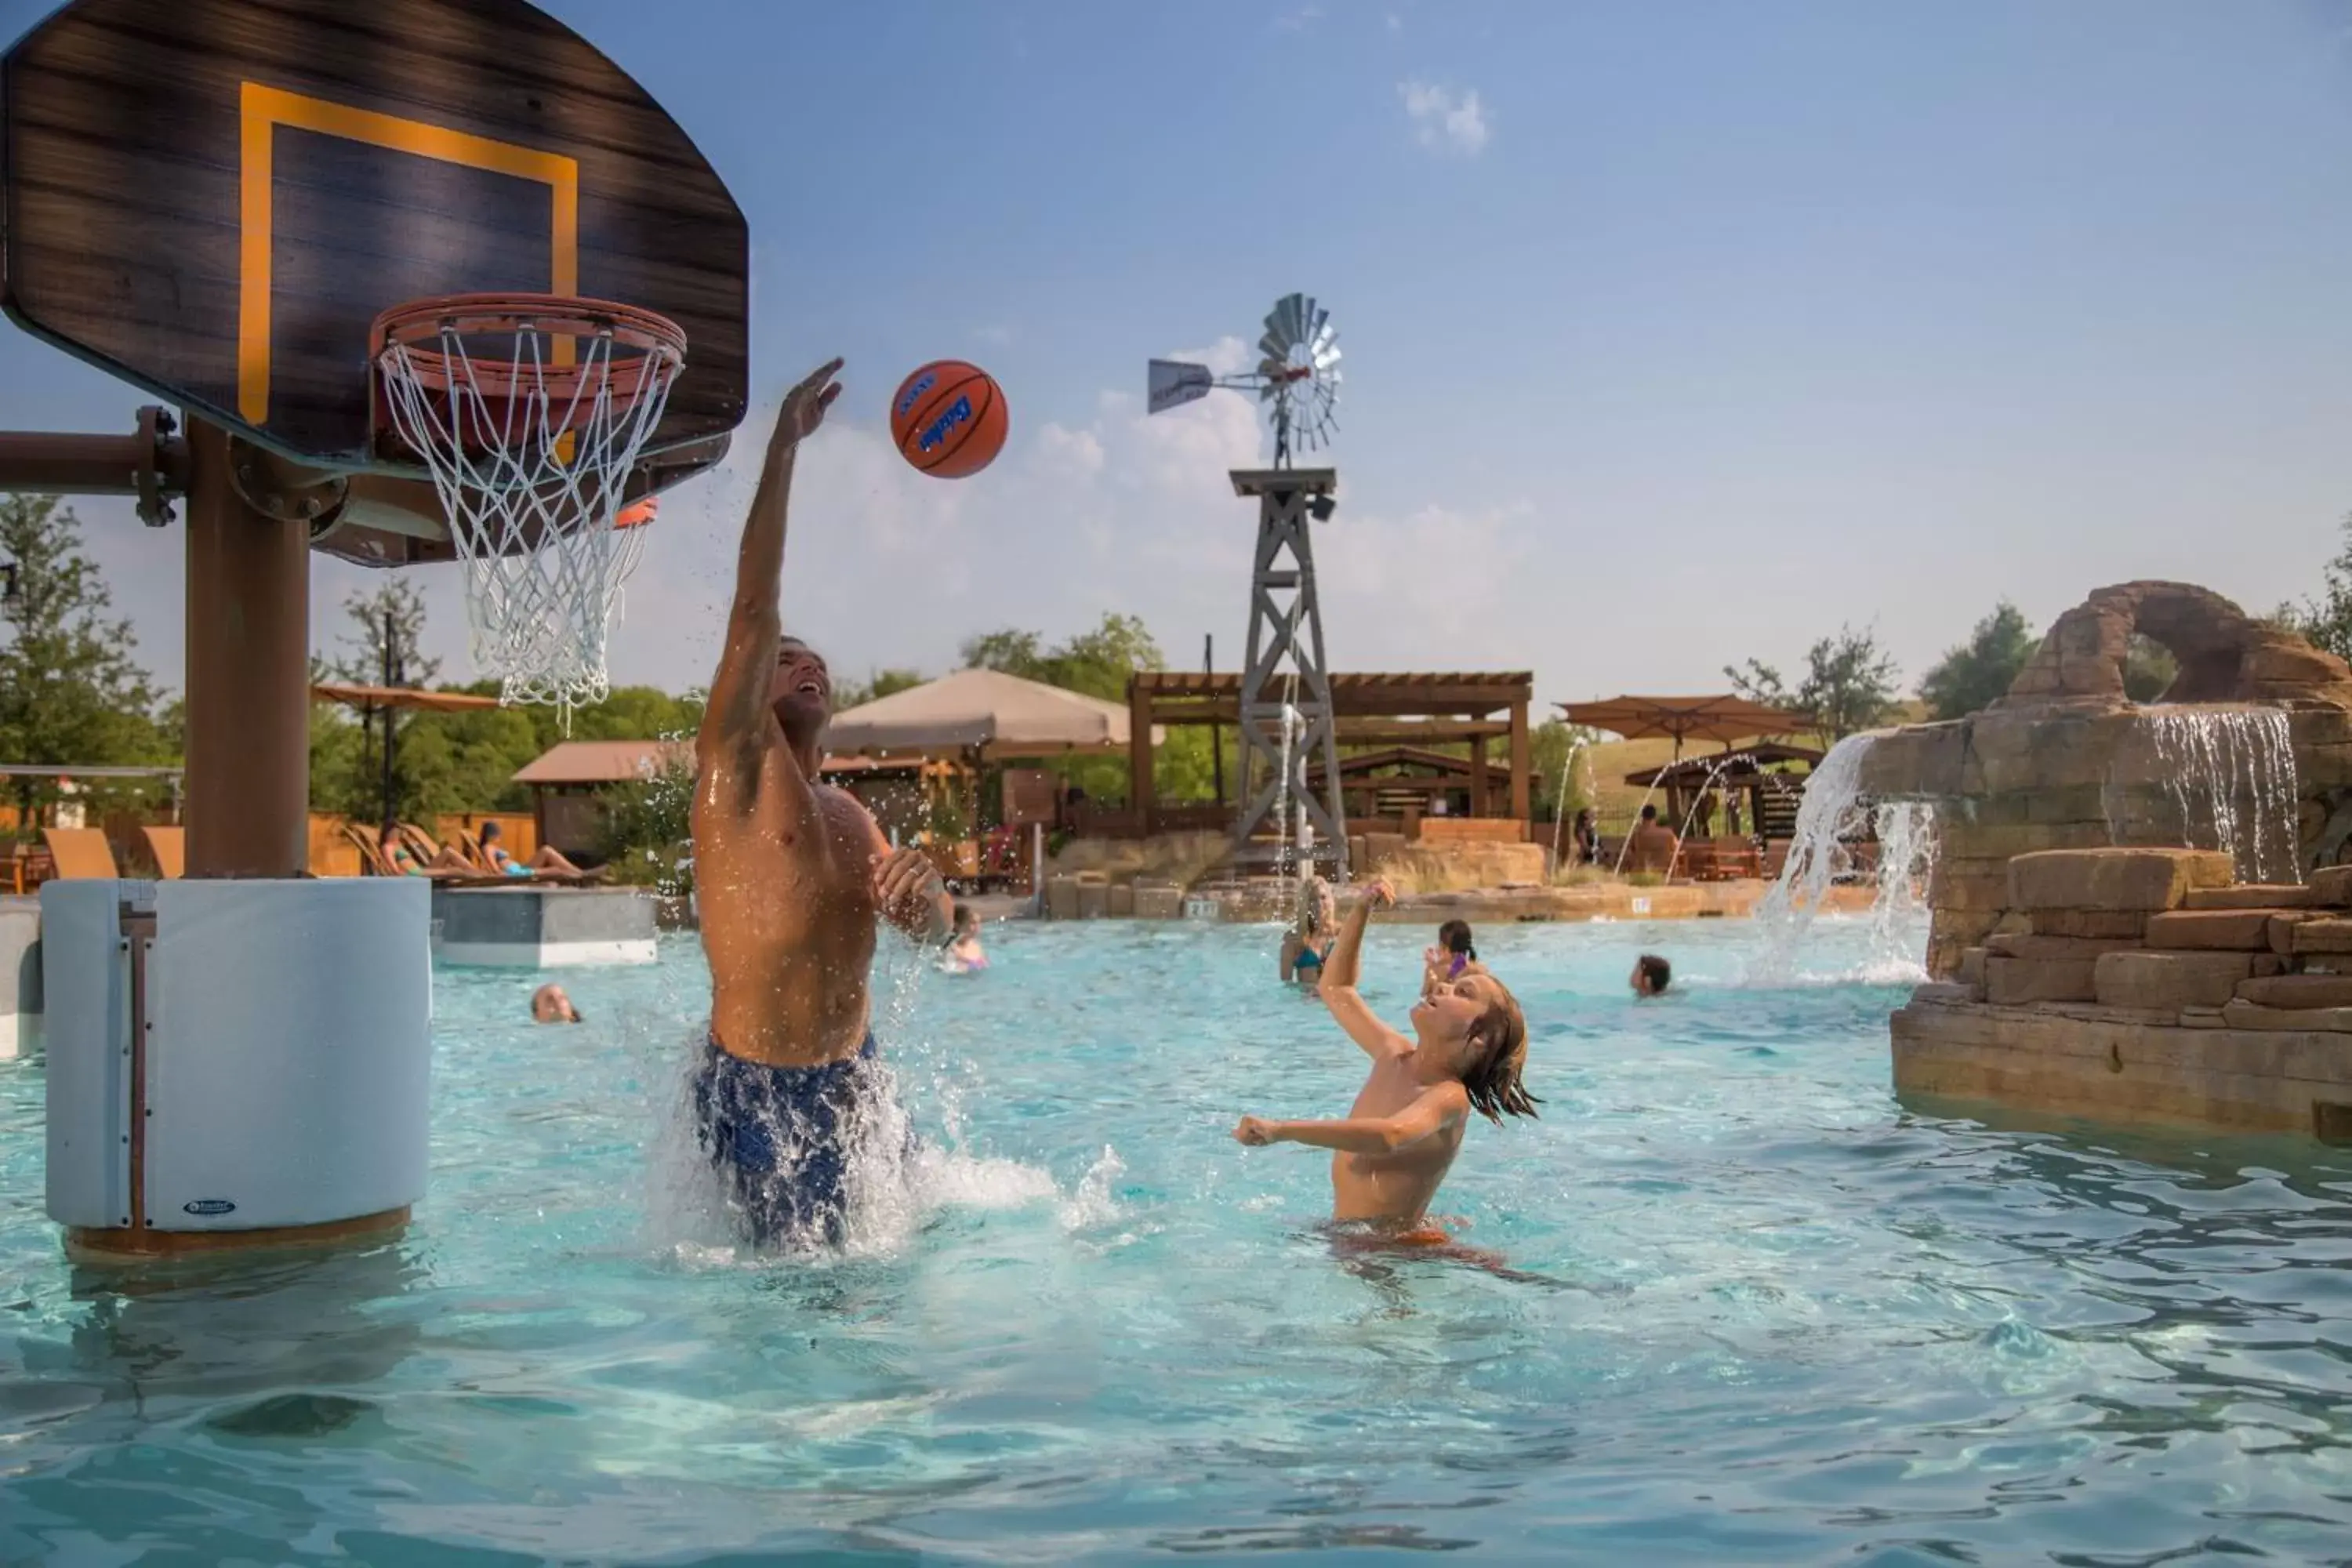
[1232,879,1536,1246]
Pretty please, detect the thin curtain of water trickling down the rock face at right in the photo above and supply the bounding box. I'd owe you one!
[2140,708,2300,881]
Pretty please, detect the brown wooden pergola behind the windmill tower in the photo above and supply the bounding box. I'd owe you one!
[1127,670,1536,832]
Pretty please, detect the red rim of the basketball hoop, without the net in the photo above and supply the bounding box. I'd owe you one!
[367,294,687,407]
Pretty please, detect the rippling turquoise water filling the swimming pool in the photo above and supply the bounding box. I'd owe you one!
[0,921,2352,1566]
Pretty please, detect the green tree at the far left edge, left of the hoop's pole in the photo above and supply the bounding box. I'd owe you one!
[0,496,176,822]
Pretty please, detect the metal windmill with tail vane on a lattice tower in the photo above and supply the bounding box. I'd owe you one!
[1136,294,1348,877]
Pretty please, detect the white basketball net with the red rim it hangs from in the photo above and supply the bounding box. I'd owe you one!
[376,320,684,734]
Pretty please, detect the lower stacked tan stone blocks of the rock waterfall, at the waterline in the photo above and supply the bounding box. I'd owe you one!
[1893,848,2352,1140]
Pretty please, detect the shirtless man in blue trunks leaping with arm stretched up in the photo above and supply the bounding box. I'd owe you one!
[694,360,950,1241]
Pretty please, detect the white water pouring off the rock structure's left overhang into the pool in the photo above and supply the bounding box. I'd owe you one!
[1748,736,1936,985]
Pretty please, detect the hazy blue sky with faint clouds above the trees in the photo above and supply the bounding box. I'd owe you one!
[0,0,2352,699]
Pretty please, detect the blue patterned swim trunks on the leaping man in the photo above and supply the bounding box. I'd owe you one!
[694,1034,875,1246]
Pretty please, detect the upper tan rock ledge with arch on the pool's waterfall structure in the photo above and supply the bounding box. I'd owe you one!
[1863,583,2352,975]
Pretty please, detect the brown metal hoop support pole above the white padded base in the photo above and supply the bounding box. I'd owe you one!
[186,423,310,877]
